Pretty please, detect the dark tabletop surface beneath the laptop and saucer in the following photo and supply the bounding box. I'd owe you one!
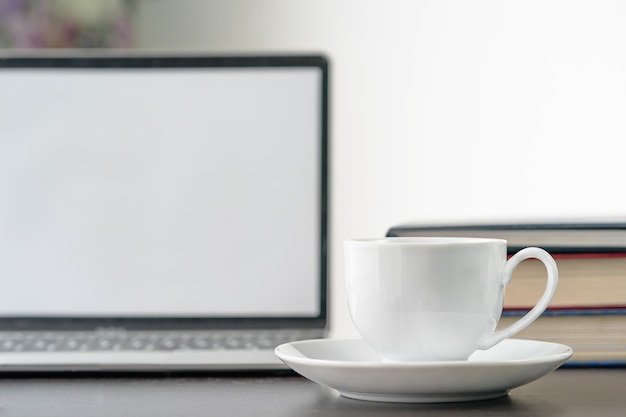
[0,368,626,417]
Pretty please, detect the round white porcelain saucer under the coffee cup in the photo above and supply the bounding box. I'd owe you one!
[275,339,573,403]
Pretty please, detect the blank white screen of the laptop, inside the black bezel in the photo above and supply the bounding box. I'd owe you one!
[0,68,321,316]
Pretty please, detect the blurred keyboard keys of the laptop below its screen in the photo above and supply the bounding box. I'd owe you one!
[0,331,307,352]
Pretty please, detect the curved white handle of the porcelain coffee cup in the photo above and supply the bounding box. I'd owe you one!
[478,247,559,350]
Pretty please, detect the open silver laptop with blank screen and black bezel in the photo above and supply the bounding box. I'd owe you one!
[0,55,328,372]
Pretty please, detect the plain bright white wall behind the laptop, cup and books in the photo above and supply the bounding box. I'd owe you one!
[138,0,626,336]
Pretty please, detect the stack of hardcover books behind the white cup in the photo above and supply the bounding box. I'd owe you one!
[388,222,626,366]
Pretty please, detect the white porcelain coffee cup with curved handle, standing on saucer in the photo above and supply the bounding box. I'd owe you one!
[345,237,558,362]
